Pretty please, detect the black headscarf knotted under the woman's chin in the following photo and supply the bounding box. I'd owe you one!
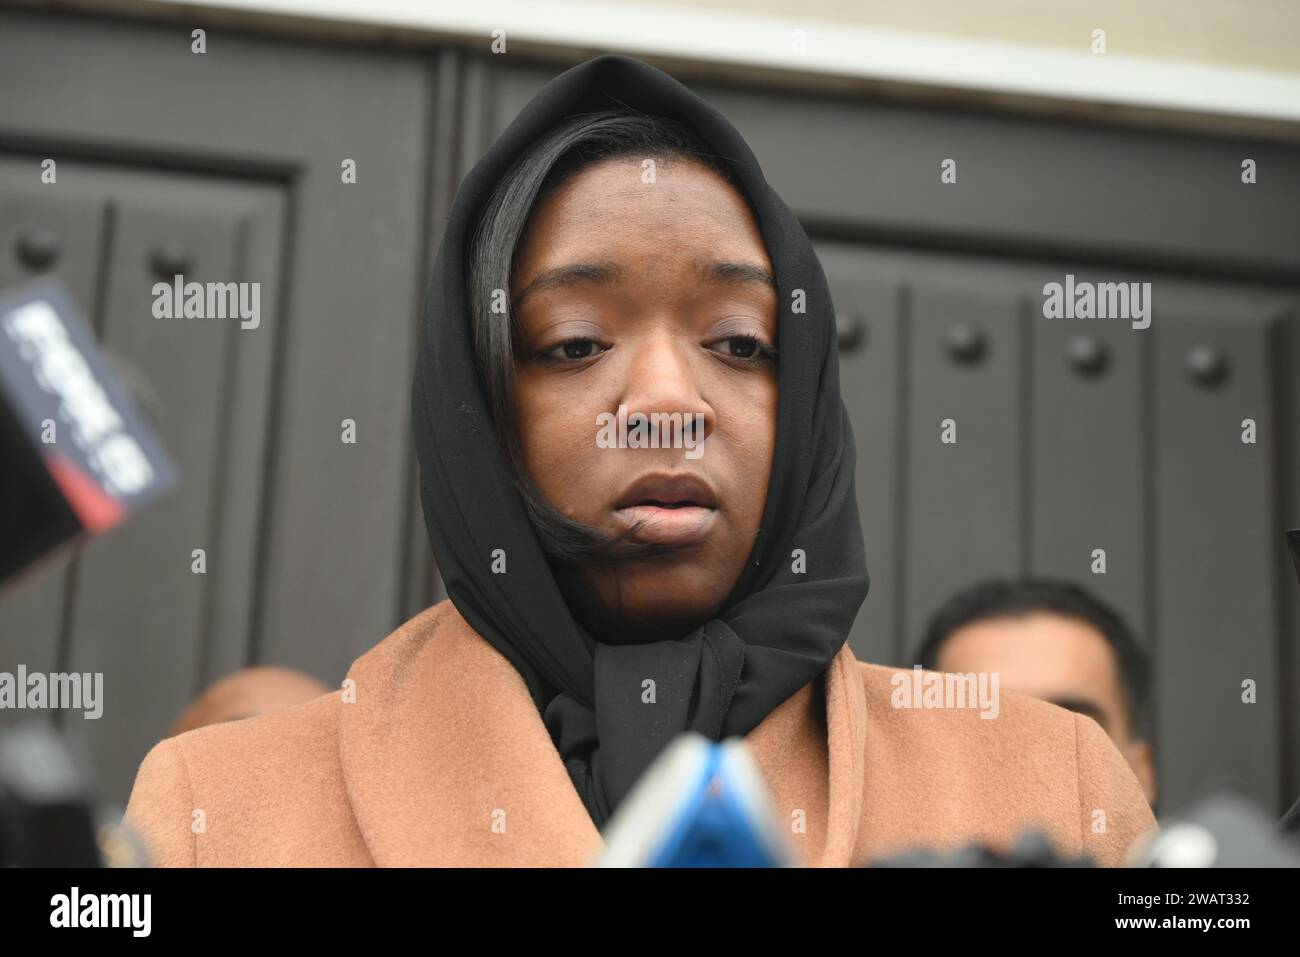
[412,55,867,827]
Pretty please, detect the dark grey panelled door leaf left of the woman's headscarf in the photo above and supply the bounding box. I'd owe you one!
[0,10,436,801]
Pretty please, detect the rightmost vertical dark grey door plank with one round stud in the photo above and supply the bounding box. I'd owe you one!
[1152,304,1282,802]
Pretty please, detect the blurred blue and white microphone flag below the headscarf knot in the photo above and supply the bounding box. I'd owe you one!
[595,732,798,867]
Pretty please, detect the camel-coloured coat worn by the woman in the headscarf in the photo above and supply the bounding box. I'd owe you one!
[125,601,1154,866]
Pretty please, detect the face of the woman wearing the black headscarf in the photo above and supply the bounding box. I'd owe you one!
[510,157,777,642]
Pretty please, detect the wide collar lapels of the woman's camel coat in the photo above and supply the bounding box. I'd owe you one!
[338,601,866,866]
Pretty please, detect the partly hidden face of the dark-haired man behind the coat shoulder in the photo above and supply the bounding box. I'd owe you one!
[937,612,1156,802]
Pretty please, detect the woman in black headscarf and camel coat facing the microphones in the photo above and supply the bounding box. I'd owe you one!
[126,56,1153,866]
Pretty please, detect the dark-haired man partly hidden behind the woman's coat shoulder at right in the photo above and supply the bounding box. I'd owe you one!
[918,579,1156,807]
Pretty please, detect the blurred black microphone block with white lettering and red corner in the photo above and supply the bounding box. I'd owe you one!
[0,277,177,583]
